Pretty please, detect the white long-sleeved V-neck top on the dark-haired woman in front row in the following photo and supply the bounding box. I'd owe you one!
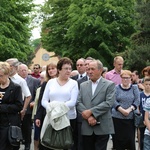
[42,78,78,119]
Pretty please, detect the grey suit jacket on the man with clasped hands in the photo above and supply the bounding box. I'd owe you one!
[77,78,115,135]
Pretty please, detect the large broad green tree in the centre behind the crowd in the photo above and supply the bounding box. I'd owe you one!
[42,0,135,67]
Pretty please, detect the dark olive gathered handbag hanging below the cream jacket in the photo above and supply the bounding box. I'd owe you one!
[41,124,73,149]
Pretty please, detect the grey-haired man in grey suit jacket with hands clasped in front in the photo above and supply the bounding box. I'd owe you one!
[77,60,115,150]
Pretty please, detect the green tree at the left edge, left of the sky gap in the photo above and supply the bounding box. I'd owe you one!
[0,0,34,62]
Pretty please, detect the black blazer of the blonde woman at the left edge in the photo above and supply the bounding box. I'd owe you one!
[0,80,23,126]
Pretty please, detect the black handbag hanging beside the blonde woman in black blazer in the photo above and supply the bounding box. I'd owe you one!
[8,125,23,146]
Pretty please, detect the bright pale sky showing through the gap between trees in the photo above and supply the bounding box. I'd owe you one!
[31,0,45,39]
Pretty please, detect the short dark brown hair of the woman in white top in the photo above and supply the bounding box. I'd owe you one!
[57,57,73,70]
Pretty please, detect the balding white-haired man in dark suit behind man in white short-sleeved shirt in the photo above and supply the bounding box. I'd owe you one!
[18,64,40,150]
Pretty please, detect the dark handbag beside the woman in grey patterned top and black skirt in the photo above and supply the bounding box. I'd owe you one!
[134,112,145,128]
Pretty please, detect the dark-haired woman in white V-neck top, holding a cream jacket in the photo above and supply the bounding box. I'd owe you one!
[42,57,78,149]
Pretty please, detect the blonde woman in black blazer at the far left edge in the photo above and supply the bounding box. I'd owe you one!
[0,62,23,150]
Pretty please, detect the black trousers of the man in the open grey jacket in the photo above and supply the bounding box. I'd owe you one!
[82,133,109,150]
